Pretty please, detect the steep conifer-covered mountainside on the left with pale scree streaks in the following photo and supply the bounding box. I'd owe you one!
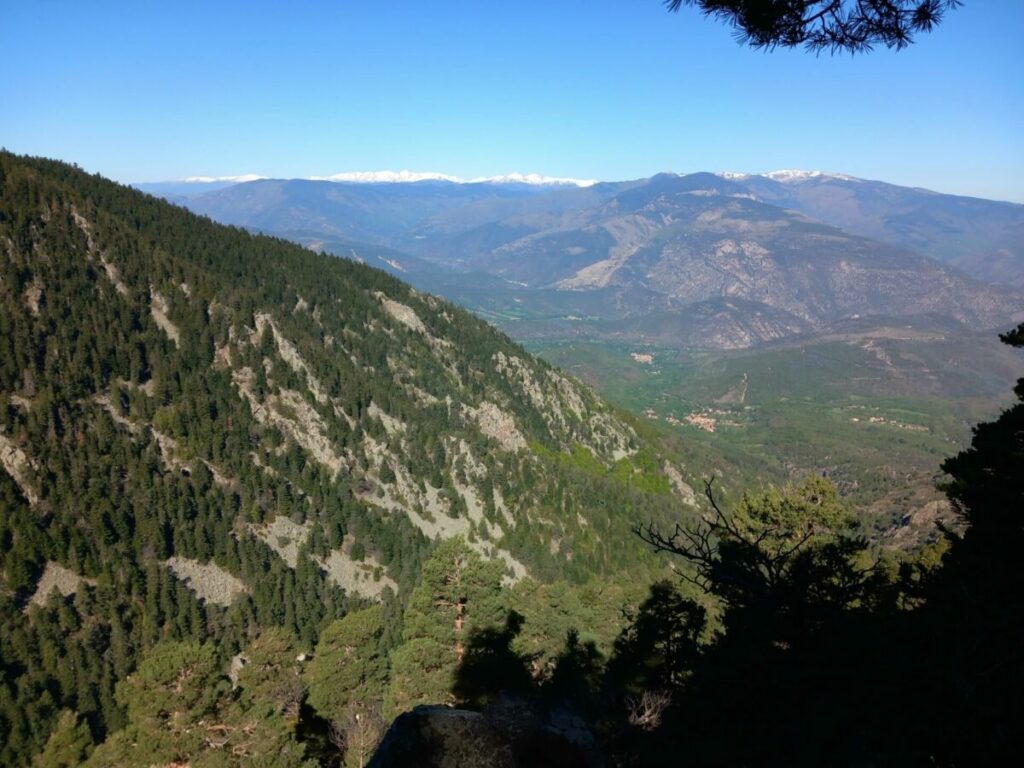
[0,153,694,765]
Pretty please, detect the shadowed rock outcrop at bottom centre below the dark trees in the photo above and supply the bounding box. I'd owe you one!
[369,700,604,768]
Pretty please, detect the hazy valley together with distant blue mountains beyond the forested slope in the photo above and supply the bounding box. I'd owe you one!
[151,171,1024,546]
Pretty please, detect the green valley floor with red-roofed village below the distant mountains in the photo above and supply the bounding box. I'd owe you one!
[527,328,1024,546]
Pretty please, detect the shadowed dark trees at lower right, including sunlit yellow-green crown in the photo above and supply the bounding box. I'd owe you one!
[630,326,1024,766]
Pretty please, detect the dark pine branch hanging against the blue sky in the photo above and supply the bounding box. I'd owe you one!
[665,0,962,53]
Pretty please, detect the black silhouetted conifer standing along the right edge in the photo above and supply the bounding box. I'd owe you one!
[920,325,1024,765]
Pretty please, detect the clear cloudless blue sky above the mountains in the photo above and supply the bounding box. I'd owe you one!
[6,0,1024,202]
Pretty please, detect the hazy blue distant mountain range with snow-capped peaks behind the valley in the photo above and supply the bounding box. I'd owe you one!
[176,171,1024,348]
